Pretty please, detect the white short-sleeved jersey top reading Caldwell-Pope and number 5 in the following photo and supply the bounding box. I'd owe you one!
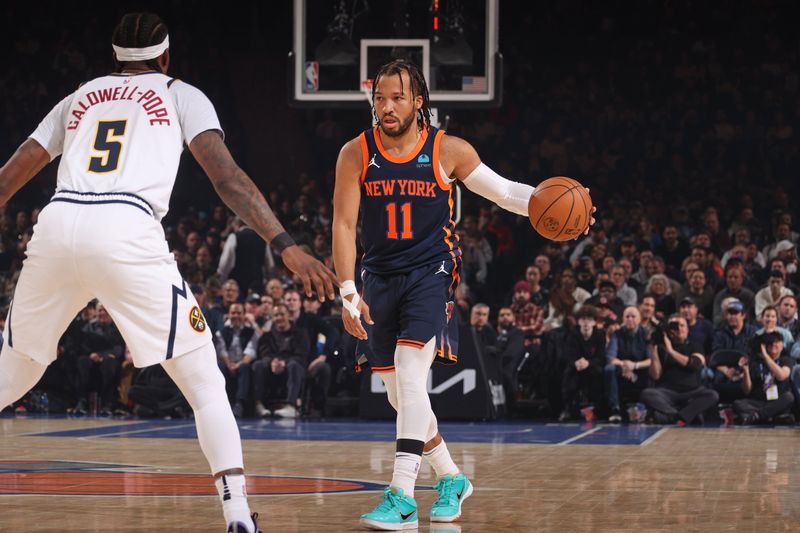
[31,72,222,220]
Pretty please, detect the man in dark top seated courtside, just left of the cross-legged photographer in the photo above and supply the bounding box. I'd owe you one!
[603,306,650,423]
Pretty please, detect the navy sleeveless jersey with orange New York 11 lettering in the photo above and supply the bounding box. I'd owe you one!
[359,126,461,275]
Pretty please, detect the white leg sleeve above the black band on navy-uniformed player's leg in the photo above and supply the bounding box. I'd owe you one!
[394,339,436,442]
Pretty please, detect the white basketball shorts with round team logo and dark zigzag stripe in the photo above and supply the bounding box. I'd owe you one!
[4,193,211,367]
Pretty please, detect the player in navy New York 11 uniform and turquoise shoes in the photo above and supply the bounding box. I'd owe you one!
[333,60,594,530]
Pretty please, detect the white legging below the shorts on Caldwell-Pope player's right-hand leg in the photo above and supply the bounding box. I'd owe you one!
[162,343,244,474]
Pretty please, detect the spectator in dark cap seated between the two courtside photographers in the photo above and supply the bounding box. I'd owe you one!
[708,298,756,402]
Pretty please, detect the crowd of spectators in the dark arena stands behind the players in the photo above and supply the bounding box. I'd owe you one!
[0,0,800,423]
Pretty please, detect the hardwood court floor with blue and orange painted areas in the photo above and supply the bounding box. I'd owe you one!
[0,417,800,533]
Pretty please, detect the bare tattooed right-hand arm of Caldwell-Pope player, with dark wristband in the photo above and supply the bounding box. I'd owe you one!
[189,130,339,302]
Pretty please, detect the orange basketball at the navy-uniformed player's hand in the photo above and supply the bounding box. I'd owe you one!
[528,176,592,241]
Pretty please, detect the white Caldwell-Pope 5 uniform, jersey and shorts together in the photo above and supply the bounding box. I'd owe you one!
[4,72,221,367]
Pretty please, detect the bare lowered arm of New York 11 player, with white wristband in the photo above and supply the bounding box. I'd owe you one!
[333,139,372,339]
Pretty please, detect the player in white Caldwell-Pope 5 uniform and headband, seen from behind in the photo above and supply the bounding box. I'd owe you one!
[0,13,338,533]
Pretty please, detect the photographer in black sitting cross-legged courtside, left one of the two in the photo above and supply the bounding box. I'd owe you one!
[640,315,719,424]
